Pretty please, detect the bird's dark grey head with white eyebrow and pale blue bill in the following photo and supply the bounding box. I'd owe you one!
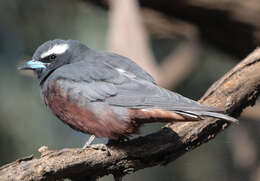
[19,39,88,84]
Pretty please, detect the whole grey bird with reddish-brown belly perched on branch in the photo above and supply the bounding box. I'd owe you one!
[18,39,238,147]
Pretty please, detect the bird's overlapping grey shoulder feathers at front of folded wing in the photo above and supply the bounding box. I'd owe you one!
[49,62,125,104]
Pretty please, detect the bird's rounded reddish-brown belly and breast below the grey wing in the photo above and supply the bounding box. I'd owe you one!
[43,82,132,139]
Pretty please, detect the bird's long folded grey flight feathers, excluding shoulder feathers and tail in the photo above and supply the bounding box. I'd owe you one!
[106,80,216,111]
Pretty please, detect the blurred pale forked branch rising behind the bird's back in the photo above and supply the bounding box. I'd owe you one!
[108,0,201,88]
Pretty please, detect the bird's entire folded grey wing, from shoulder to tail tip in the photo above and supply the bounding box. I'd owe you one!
[51,62,235,121]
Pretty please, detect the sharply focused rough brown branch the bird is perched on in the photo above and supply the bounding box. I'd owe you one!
[0,48,260,181]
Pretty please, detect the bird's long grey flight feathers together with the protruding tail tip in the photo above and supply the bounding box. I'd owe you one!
[106,80,238,122]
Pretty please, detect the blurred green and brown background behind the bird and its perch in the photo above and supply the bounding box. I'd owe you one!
[0,0,260,181]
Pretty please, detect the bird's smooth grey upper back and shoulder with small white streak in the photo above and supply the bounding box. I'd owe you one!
[47,50,156,84]
